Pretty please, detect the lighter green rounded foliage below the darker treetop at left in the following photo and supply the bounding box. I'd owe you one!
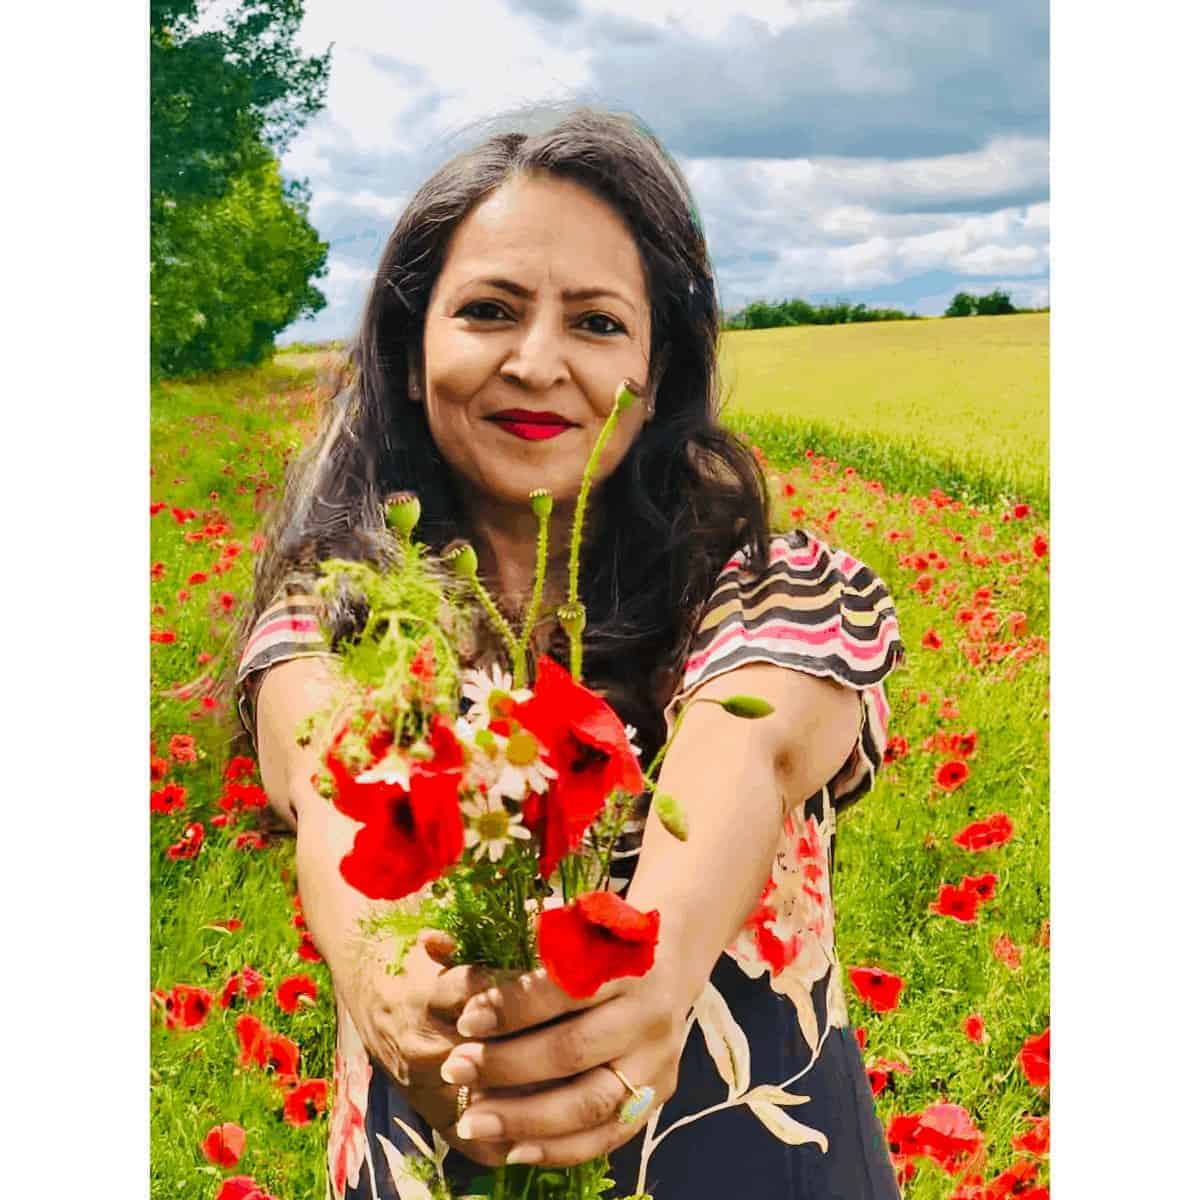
[150,158,328,376]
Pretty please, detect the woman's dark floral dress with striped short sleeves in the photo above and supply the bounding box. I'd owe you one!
[240,530,904,1200]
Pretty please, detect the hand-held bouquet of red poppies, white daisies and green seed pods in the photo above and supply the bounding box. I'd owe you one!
[301,382,770,1200]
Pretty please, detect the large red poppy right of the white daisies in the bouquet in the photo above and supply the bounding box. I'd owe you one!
[512,655,646,880]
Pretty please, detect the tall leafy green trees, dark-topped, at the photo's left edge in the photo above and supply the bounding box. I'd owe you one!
[150,0,330,376]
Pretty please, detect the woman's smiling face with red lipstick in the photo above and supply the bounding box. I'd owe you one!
[420,175,650,509]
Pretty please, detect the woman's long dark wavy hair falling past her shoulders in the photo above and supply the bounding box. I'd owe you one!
[241,108,768,756]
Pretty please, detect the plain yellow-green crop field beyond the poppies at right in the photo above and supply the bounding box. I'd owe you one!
[721,313,1050,498]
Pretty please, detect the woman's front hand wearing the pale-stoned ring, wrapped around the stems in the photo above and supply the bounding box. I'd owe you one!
[442,943,695,1166]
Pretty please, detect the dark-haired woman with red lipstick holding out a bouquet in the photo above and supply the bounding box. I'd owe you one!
[239,110,902,1200]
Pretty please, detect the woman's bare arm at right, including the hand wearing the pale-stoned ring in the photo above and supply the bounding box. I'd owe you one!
[443,665,860,1164]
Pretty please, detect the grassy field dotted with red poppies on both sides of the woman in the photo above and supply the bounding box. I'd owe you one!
[149,340,1050,1200]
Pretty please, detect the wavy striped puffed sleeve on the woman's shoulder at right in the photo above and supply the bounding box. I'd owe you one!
[668,529,905,809]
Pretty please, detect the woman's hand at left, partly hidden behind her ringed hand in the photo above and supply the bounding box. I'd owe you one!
[340,930,510,1166]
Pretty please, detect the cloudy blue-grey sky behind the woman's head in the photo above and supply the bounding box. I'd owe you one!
[267,0,1050,342]
